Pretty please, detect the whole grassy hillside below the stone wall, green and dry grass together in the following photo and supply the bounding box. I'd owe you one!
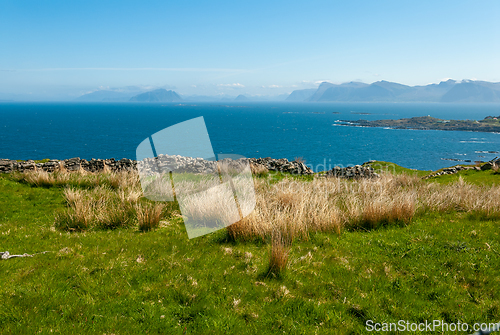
[0,167,500,334]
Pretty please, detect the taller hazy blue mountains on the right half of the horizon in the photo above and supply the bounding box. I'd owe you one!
[286,79,500,102]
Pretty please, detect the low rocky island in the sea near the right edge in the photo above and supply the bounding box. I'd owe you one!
[336,116,500,133]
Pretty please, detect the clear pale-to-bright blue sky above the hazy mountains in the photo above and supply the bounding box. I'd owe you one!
[0,0,500,98]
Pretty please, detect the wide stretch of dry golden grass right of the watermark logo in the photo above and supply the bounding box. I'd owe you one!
[227,174,500,239]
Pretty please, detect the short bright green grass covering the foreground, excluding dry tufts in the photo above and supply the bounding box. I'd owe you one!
[0,167,500,334]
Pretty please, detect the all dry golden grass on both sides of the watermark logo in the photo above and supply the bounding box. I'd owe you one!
[18,166,500,236]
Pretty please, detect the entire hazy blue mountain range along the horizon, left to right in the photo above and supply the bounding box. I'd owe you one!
[69,79,500,103]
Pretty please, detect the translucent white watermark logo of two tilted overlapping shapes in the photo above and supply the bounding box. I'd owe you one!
[136,117,255,239]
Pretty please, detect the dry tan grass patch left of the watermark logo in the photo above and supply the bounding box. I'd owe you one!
[49,171,170,231]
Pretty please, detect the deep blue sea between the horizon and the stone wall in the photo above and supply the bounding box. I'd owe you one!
[0,102,500,171]
